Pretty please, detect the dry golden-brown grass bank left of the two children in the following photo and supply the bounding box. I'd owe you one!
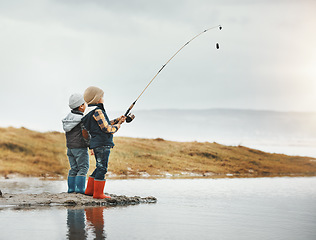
[0,127,68,177]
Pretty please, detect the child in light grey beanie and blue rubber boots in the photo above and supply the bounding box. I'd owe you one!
[62,93,89,193]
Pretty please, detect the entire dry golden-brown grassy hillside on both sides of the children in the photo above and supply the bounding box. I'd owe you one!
[0,128,316,177]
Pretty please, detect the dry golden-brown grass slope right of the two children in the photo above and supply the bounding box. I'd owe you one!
[109,138,316,176]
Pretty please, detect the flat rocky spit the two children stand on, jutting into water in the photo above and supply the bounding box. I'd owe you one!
[0,191,157,208]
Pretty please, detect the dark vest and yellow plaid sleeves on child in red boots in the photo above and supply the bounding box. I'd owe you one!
[82,103,118,148]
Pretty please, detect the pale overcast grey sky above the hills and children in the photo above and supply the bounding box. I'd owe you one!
[0,0,316,131]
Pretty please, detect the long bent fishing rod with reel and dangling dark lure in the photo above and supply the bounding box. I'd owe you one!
[124,25,222,123]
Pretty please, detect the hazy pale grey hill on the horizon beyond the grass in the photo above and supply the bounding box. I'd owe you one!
[109,109,316,143]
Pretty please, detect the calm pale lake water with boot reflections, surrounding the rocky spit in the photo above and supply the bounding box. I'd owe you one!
[0,177,316,240]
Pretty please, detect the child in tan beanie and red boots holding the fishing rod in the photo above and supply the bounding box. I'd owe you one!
[82,87,126,199]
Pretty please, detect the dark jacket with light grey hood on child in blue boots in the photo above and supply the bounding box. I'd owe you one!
[62,110,89,148]
